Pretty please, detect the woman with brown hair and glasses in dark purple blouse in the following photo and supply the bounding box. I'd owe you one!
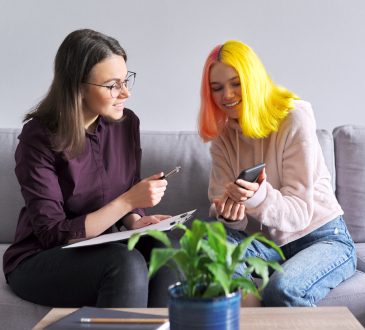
[4,29,175,307]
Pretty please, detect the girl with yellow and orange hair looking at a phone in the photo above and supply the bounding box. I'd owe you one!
[199,41,356,306]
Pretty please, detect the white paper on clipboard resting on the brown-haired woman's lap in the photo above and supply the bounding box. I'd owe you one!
[62,210,196,249]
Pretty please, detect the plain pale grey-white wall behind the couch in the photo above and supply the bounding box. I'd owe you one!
[0,0,365,130]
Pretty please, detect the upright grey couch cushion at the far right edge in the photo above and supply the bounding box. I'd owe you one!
[333,125,365,242]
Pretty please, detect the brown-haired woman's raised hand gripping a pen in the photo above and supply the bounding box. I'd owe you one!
[121,172,167,209]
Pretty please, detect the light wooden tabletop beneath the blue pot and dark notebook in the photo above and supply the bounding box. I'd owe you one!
[33,307,364,330]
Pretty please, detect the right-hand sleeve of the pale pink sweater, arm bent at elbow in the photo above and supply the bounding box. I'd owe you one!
[246,103,319,232]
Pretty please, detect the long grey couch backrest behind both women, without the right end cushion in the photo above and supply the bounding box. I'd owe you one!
[0,128,348,243]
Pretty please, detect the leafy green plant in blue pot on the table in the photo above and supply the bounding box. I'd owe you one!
[128,220,284,330]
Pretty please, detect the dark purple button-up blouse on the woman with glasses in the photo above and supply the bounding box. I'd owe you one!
[4,109,144,274]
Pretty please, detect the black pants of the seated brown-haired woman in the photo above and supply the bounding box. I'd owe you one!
[8,237,178,308]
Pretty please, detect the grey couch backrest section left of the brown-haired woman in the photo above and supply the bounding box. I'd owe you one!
[0,128,23,243]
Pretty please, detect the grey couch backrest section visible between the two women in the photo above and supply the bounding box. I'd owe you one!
[141,131,210,222]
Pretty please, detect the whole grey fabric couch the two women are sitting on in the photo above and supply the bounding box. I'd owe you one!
[0,125,365,329]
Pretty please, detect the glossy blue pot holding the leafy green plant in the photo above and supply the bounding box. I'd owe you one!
[169,283,241,330]
